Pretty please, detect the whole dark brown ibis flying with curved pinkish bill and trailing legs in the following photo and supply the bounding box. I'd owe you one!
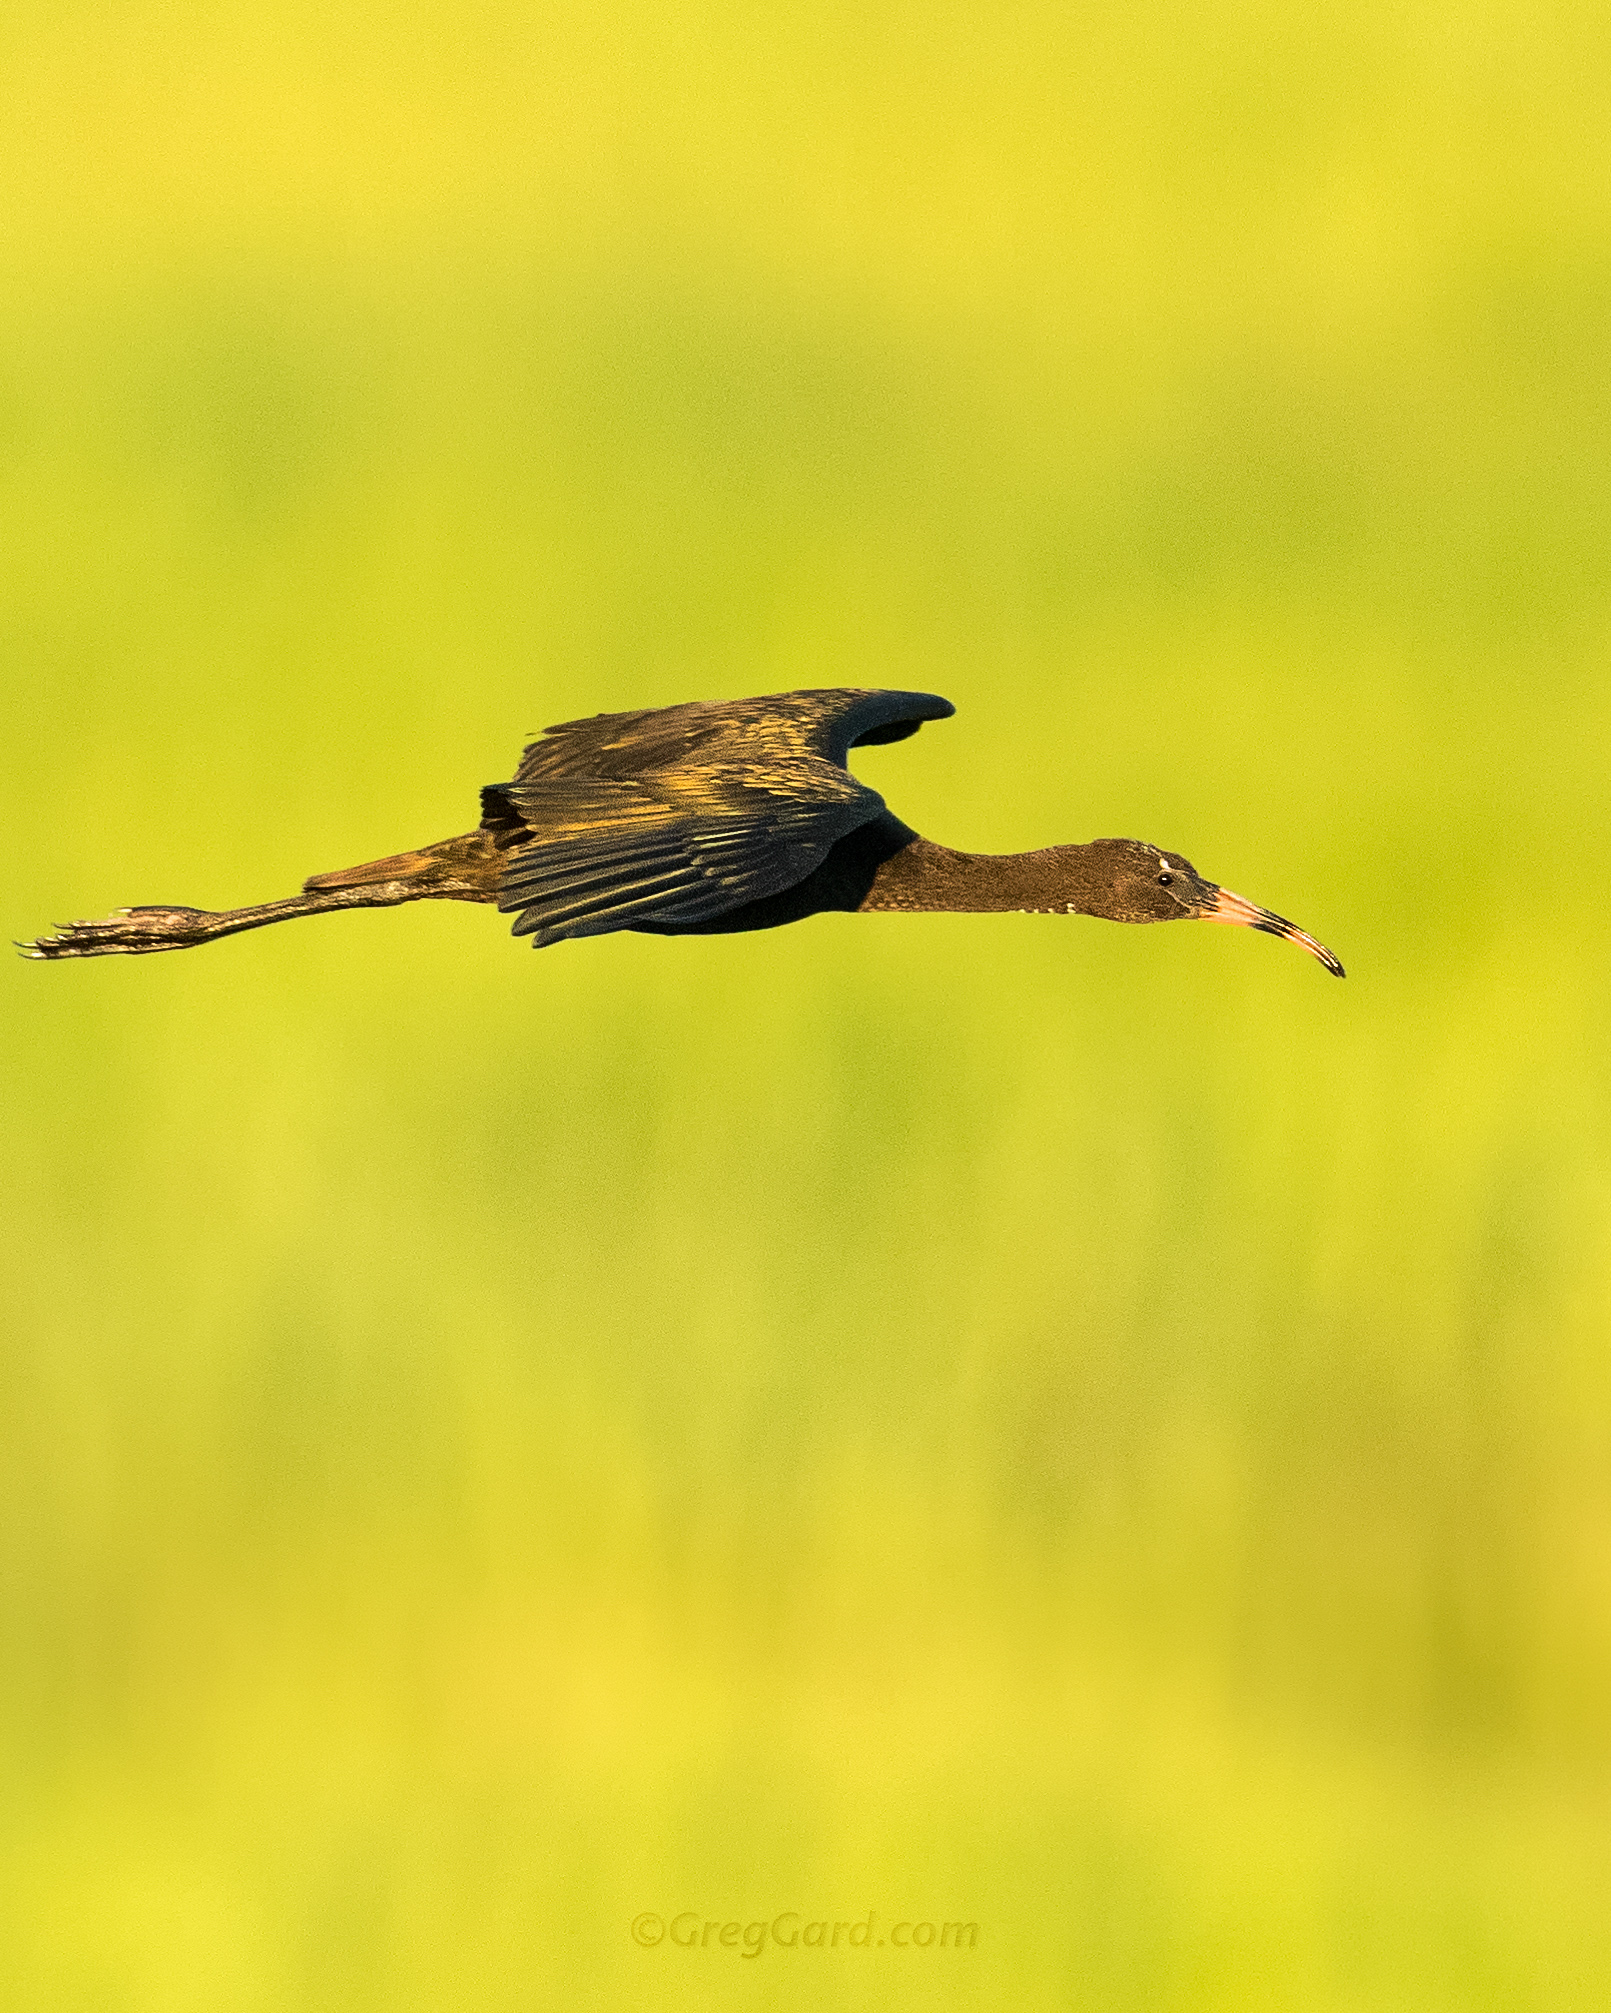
[18,690,1343,978]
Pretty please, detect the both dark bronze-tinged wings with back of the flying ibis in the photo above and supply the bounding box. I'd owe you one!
[483,690,955,946]
